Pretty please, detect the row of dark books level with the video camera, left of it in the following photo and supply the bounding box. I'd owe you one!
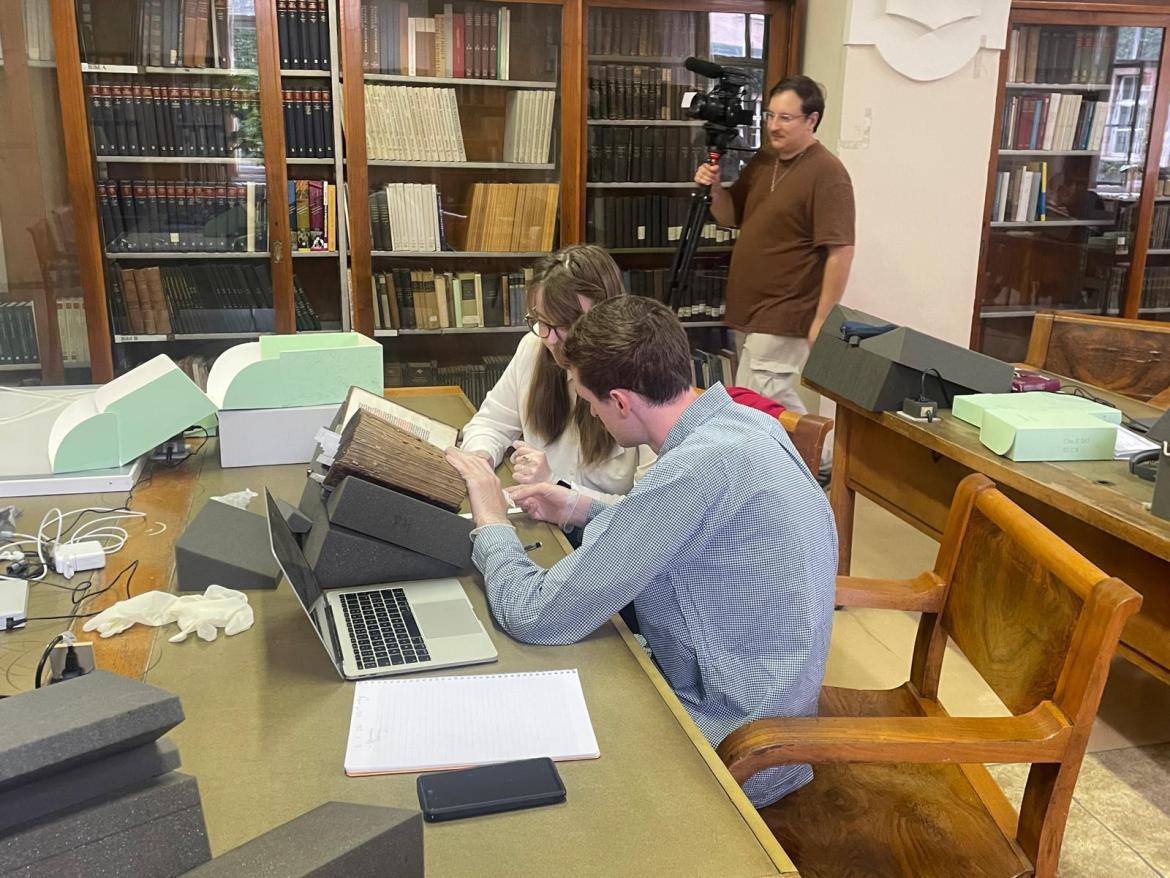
[589,64,707,119]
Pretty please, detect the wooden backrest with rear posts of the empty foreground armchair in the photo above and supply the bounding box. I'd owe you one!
[911,474,1142,873]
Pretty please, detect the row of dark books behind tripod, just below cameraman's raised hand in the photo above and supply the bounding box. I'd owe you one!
[589,196,738,248]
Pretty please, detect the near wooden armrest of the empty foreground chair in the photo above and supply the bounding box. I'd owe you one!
[718,701,1072,783]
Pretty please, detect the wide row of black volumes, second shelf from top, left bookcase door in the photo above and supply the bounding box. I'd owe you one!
[85,83,262,158]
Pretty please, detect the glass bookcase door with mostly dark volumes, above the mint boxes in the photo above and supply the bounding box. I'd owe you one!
[77,0,297,375]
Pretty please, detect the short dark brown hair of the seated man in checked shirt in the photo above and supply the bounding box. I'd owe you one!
[560,296,690,405]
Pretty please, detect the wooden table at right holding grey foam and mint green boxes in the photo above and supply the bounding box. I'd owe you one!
[806,382,1170,682]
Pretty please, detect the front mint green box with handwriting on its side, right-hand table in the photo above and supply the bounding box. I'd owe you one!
[979,407,1117,460]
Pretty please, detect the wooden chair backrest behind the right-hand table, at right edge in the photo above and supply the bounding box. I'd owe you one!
[1026,311,1170,402]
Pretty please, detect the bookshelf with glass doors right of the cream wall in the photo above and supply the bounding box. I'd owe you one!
[971,0,1170,361]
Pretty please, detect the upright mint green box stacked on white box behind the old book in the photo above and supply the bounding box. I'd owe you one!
[207,332,383,410]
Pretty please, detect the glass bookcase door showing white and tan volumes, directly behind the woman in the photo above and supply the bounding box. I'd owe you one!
[360,0,562,404]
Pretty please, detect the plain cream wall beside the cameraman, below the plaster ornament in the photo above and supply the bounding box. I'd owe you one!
[805,8,999,347]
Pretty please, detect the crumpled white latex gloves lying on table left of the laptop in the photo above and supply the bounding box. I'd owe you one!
[83,585,255,643]
